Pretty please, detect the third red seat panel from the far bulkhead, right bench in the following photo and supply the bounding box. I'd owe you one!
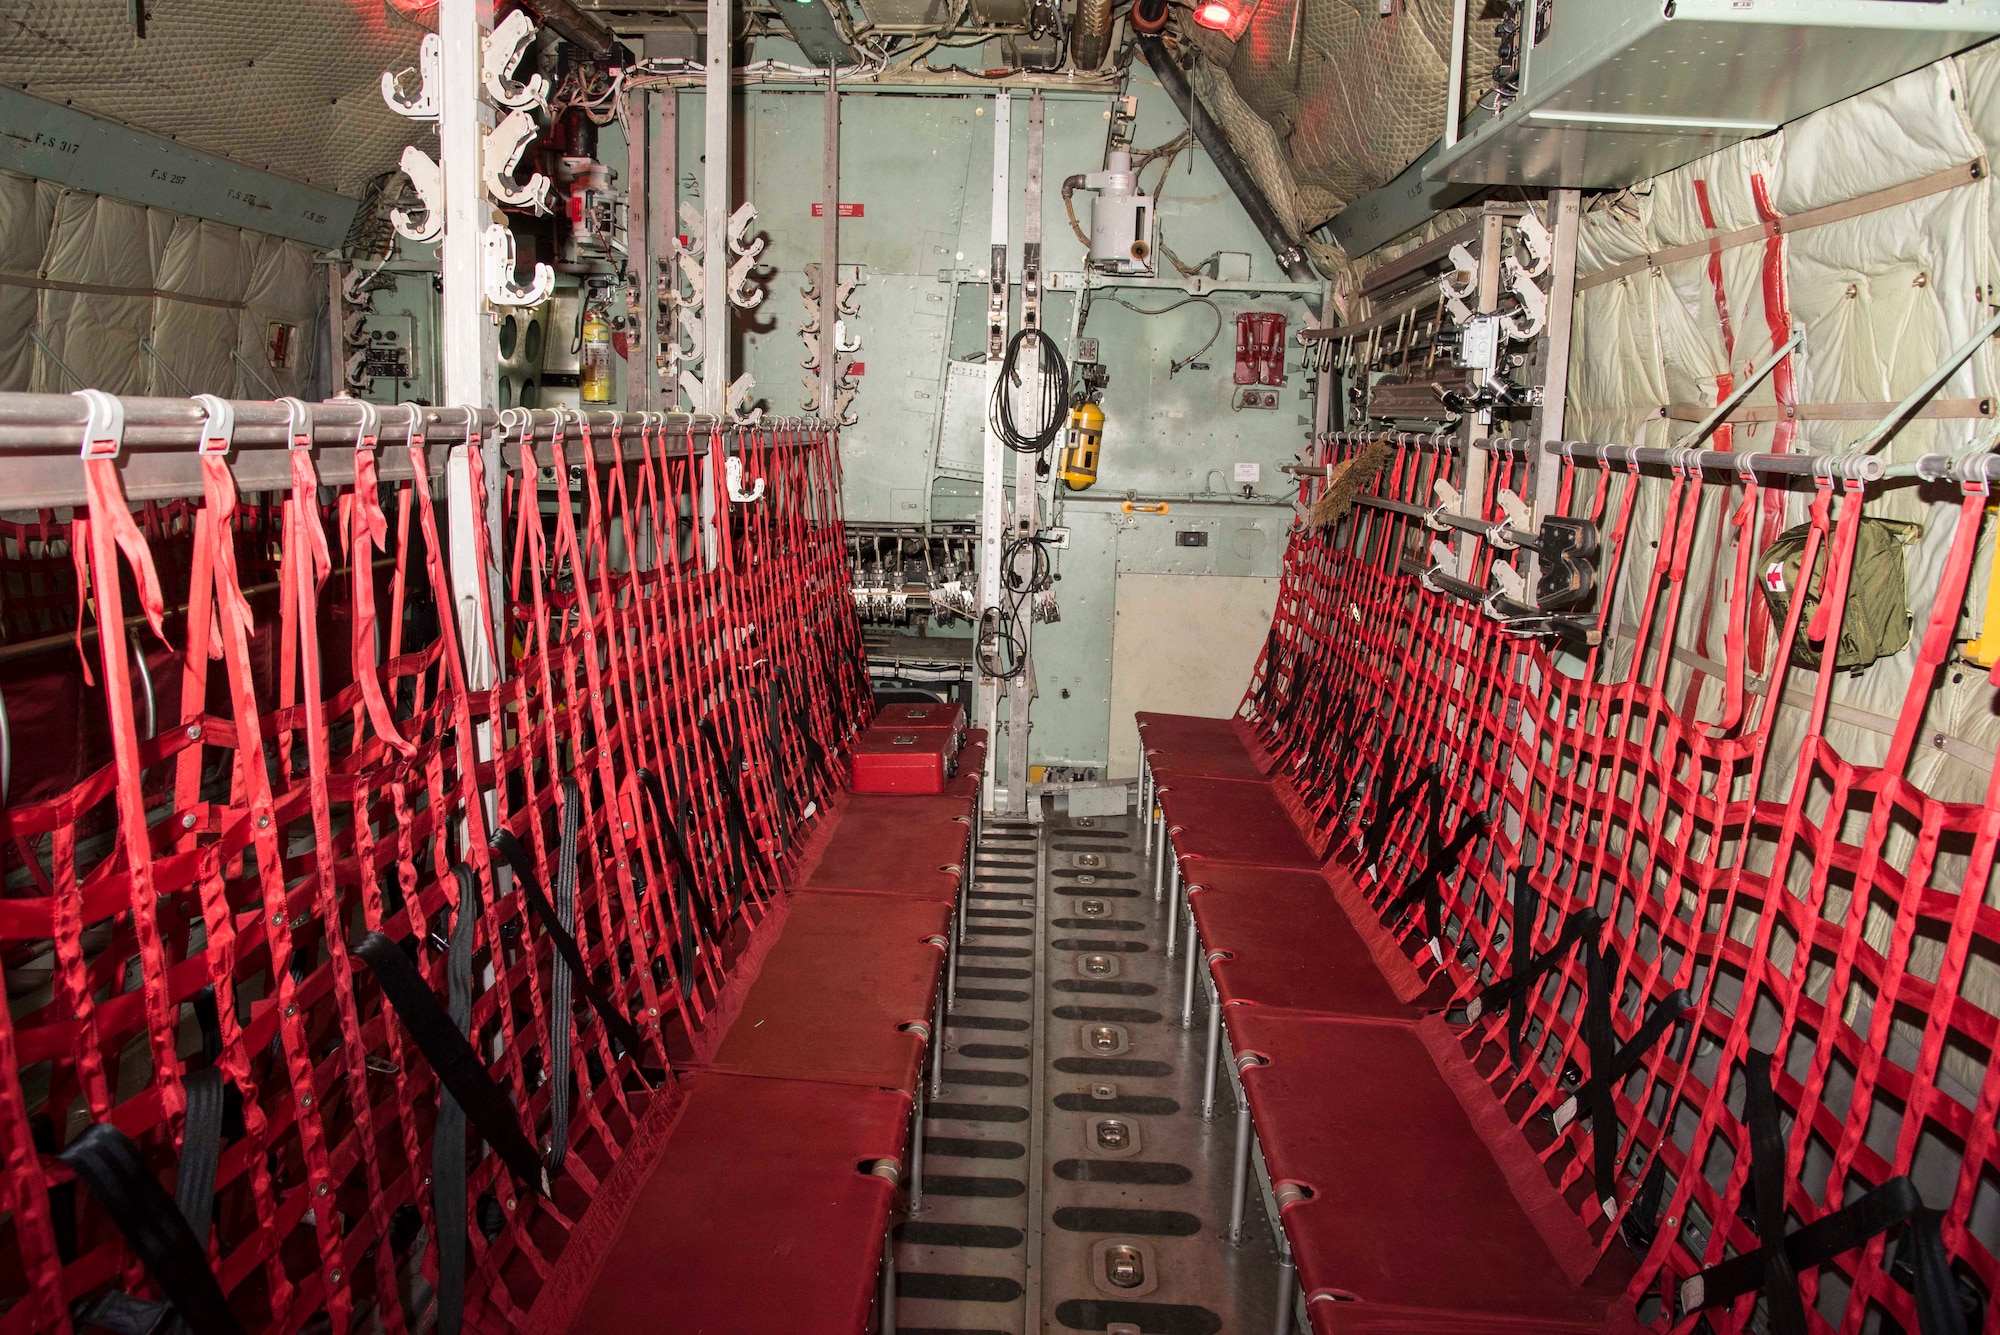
[1188,863,1416,1019]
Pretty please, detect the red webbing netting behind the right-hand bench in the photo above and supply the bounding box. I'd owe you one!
[1240,436,2000,1331]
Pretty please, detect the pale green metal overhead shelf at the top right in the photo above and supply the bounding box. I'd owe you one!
[1424,0,2000,190]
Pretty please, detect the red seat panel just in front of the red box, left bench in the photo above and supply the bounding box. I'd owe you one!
[804,793,972,901]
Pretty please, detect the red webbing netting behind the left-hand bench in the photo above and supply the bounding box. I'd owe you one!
[0,406,868,1333]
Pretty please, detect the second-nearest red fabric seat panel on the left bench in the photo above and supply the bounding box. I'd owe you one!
[708,889,952,1093]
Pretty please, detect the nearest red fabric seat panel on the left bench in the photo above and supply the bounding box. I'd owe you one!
[570,1071,910,1335]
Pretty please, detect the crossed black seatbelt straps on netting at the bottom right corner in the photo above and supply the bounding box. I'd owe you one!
[1680,1087,1980,1335]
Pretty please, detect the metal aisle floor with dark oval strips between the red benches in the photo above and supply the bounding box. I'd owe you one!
[896,815,1278,1335]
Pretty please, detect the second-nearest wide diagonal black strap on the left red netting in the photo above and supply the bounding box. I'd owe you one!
[354,903,546,1195]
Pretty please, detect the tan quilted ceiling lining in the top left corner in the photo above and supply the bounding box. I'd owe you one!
[0,0,428,196]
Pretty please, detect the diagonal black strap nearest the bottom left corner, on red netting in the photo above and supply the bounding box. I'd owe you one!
[56,1099,242,1335]
